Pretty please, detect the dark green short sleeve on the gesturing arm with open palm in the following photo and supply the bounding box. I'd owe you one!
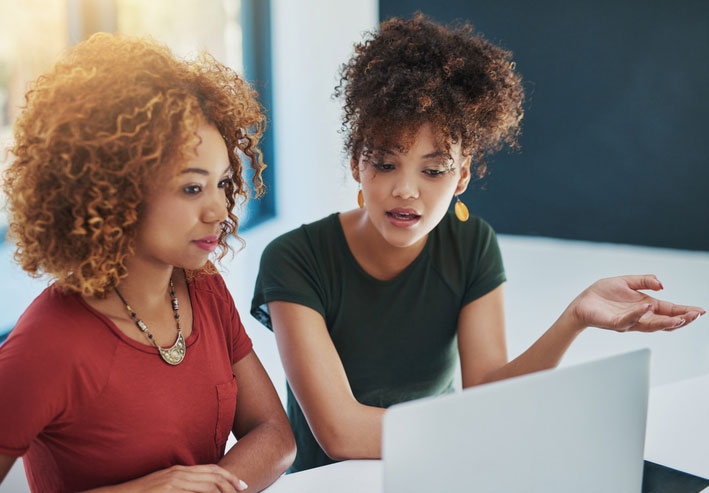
[461,219,507,307]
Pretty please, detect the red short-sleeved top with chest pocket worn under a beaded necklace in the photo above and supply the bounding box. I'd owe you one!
[0,275,251,492]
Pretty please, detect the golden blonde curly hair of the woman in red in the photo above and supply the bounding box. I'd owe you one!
[3,33,265,296]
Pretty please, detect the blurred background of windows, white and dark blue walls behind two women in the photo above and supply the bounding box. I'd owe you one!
[0,0,709,492]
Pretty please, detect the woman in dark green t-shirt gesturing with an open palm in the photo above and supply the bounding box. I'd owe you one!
[251,15,704,471]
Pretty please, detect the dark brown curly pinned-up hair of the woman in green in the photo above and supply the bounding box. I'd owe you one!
[335,13,524,177]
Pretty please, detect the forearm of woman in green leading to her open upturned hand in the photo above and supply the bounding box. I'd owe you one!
[472,309,585,387]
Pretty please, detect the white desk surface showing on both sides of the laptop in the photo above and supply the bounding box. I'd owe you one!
[265,375,709,493]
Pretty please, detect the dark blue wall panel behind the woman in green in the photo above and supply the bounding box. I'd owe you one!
[380,0,709,250]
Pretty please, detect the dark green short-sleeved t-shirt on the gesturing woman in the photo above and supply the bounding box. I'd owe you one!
[251,209,505,472]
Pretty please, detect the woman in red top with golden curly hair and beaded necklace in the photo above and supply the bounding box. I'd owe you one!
[0,34,295,491]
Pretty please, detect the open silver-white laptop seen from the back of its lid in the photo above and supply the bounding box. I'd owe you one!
[382,349,650,493]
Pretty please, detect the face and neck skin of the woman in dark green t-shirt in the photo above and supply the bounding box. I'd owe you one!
[342,124,470,279]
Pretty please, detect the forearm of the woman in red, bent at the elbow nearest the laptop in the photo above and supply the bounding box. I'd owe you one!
[219,421,295,491]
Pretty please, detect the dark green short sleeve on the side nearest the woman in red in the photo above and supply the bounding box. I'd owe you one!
[251,227,326,330]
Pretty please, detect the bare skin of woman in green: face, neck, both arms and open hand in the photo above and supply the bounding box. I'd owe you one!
[268,125,705,459]
